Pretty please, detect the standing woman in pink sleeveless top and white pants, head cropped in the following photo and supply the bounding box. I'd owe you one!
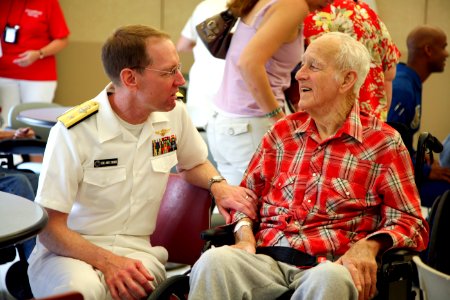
[207,0,331,185]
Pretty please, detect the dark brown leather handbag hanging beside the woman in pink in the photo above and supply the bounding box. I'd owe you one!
[196,10,238,59]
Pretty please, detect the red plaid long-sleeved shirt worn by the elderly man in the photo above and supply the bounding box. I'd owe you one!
[234,104,428,255]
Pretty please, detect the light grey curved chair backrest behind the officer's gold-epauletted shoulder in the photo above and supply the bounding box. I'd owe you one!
[7,102,61,141]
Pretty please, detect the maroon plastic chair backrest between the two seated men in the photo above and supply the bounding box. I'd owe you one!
[150,174,212,265]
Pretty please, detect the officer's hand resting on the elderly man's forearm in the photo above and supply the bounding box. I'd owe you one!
[211,181,258,223]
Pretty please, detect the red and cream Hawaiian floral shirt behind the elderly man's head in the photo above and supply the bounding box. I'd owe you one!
[304,0,400,121]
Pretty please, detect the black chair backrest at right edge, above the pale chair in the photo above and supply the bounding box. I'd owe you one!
[422,190,450,275]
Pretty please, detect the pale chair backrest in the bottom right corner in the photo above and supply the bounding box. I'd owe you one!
[413,256,450,300]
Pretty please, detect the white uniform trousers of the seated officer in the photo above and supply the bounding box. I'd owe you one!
[28,235,168,300]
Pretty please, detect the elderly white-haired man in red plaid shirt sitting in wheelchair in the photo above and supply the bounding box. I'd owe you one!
[189,32,428,299]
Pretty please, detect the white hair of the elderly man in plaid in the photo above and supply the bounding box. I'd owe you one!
[317,32,371,95]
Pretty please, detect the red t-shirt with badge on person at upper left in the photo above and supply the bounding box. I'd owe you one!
[0,0,69,80]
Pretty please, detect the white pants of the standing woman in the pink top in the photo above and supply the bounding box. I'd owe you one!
[206,113,273,185]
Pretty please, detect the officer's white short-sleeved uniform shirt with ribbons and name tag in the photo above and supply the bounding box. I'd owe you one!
[35,86,208,236]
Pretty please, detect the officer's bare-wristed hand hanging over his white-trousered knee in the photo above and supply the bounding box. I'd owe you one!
[101,255,154,299]
